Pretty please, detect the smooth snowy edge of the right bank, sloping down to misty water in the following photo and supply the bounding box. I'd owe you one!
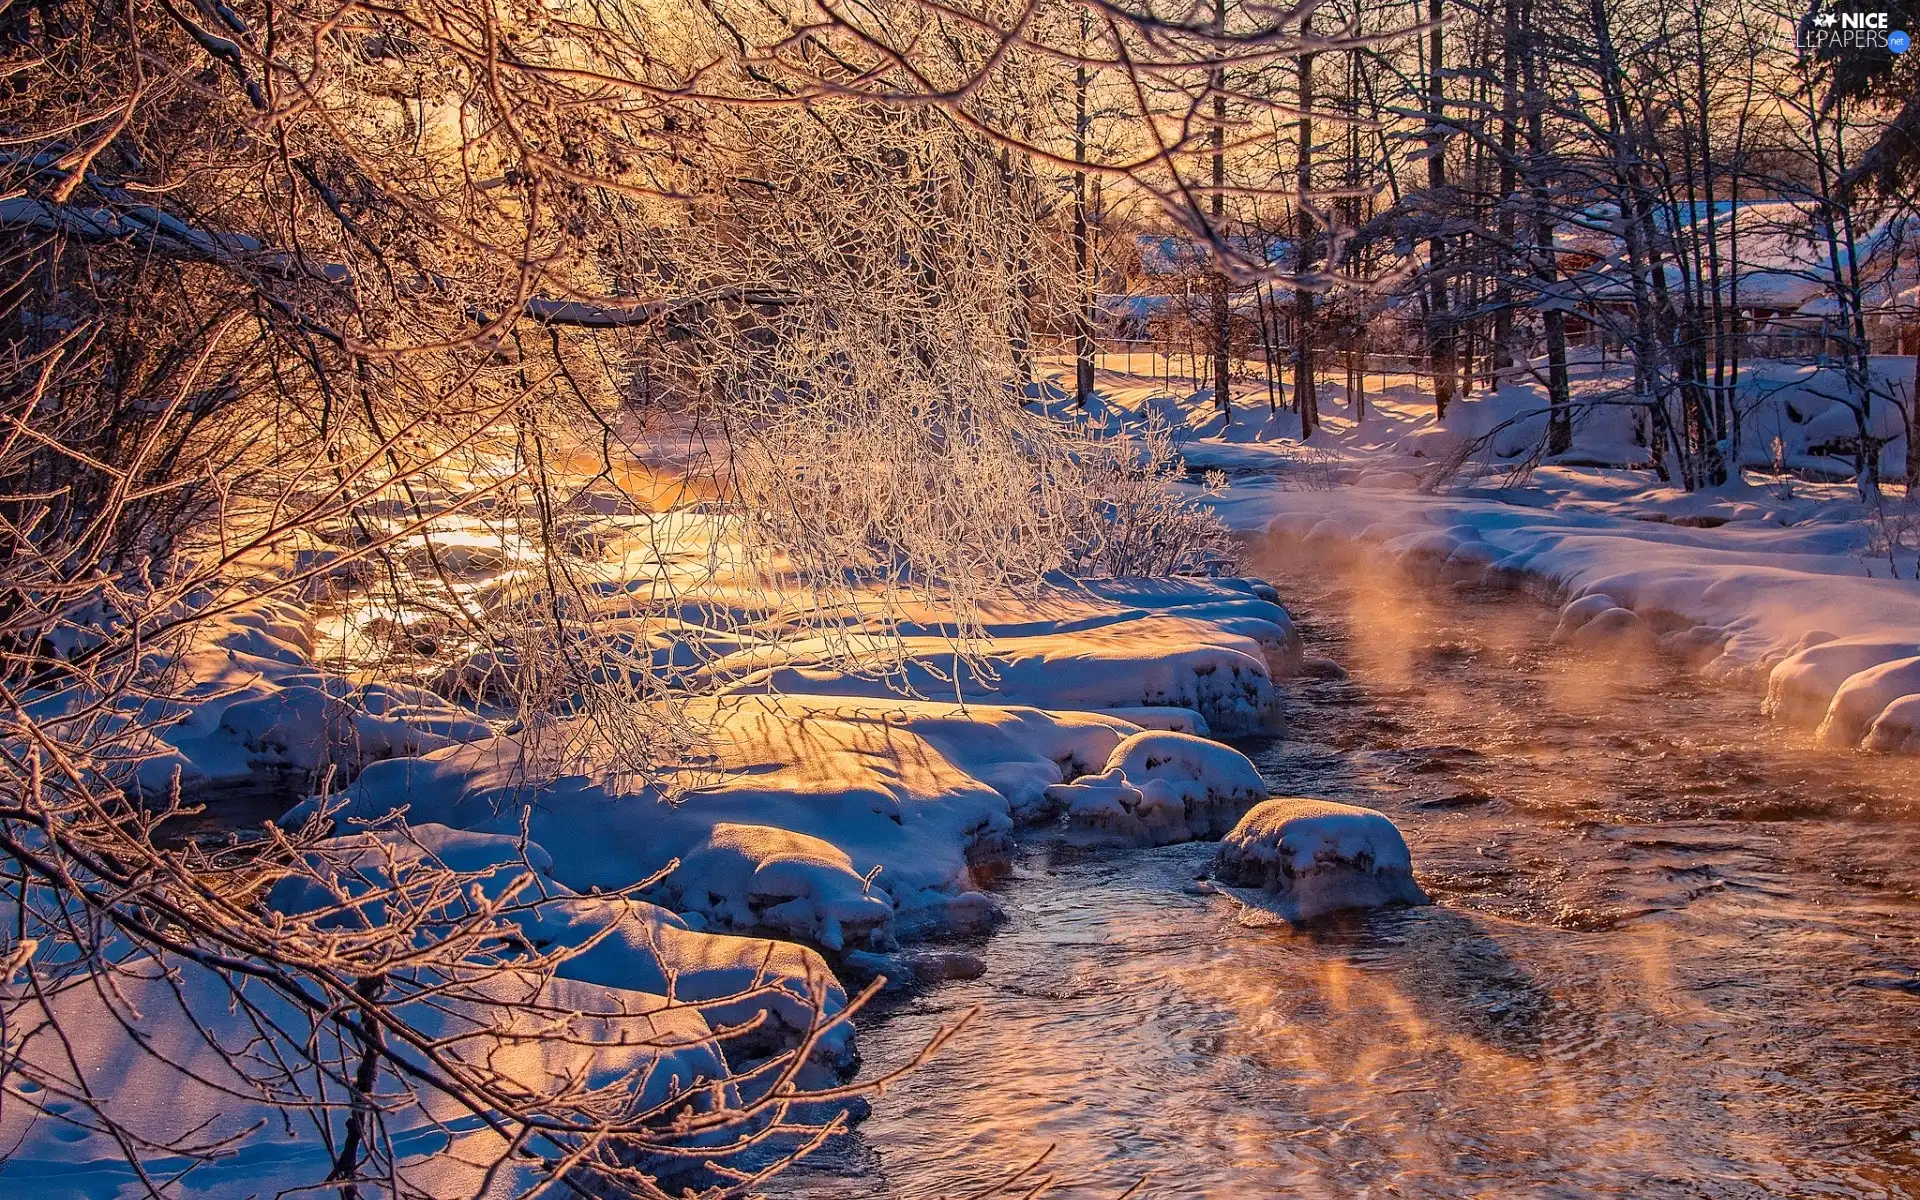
[1219,470,1920,753]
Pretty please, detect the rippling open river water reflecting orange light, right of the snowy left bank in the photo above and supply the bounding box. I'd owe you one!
[776,549,1920,1198]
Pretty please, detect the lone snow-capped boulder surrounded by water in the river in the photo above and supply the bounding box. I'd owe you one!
[1210,799,1428,922]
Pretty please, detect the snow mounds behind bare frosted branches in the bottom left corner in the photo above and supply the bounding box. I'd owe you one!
[0,921,726,1200]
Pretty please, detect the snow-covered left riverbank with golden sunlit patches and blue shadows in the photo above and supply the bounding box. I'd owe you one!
[0,555,1298,1196]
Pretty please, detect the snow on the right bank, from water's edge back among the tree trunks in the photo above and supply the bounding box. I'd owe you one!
[1054,351,1920,749]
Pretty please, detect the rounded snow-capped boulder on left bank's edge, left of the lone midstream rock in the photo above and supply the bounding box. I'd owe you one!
[660,824,893,950]
